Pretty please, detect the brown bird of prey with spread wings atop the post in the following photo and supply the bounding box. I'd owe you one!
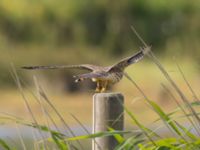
[22,46,151,92]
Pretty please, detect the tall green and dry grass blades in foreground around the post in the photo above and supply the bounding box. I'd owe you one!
[0,42,200,150]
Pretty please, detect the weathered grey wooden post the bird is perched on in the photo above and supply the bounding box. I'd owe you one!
[92,93,124,150]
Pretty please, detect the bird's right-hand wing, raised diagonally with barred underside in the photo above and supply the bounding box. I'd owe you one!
[109,47,150,71]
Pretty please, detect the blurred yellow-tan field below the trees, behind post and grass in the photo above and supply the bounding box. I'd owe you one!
[0,56,200,123]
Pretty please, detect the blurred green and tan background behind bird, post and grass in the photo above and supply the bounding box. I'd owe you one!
[0,0,200,148]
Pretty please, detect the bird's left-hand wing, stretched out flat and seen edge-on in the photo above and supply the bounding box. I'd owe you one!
[22,64,98,71]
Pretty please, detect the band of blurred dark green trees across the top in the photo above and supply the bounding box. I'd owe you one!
[0,0,200,55]
